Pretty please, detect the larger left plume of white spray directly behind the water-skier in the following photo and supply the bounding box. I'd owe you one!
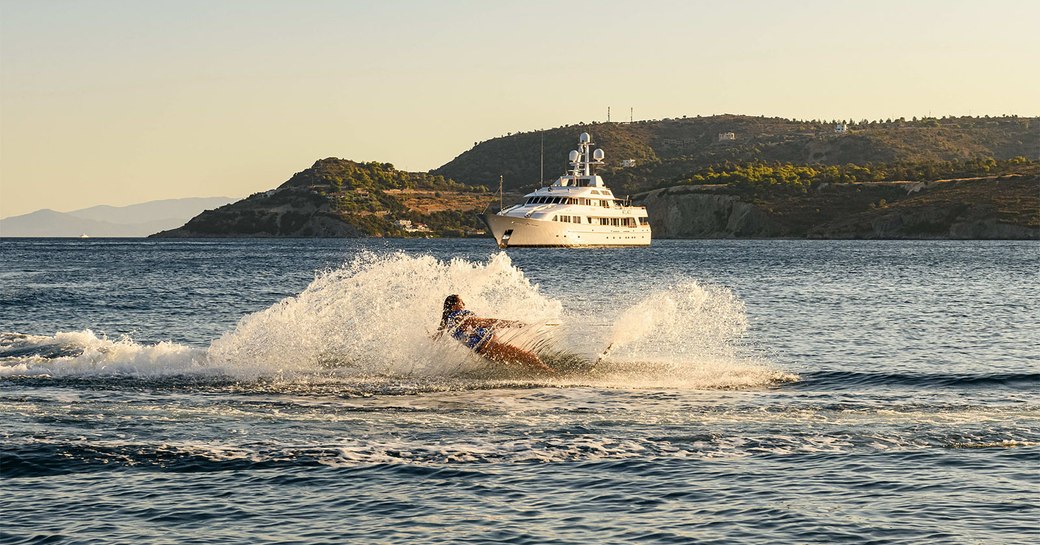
[209,253,562,375]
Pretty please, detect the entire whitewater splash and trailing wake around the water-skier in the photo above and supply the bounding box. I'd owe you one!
[0,253,790,388]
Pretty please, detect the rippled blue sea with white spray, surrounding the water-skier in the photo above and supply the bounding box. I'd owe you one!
[0,238,1040,544]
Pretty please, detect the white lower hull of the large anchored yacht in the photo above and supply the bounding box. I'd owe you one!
[482,214,651,248]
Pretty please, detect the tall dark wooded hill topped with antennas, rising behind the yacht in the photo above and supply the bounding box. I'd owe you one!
[431,114,1040,194]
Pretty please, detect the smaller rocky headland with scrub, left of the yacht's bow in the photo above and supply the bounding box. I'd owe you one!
[154,157,494,237]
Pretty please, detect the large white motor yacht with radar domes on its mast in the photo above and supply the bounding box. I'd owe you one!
[480,132,651,248]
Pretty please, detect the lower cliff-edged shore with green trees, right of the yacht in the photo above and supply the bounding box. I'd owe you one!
[636,176,1040,239]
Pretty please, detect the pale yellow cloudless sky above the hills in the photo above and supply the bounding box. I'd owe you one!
[0,0,1040,217]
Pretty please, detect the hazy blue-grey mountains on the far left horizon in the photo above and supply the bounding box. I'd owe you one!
[0,197,234,237]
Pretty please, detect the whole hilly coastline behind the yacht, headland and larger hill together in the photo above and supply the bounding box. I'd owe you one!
[154,115,1040,238]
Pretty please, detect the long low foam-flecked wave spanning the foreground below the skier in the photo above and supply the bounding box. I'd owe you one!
[0,429,1040,478]
